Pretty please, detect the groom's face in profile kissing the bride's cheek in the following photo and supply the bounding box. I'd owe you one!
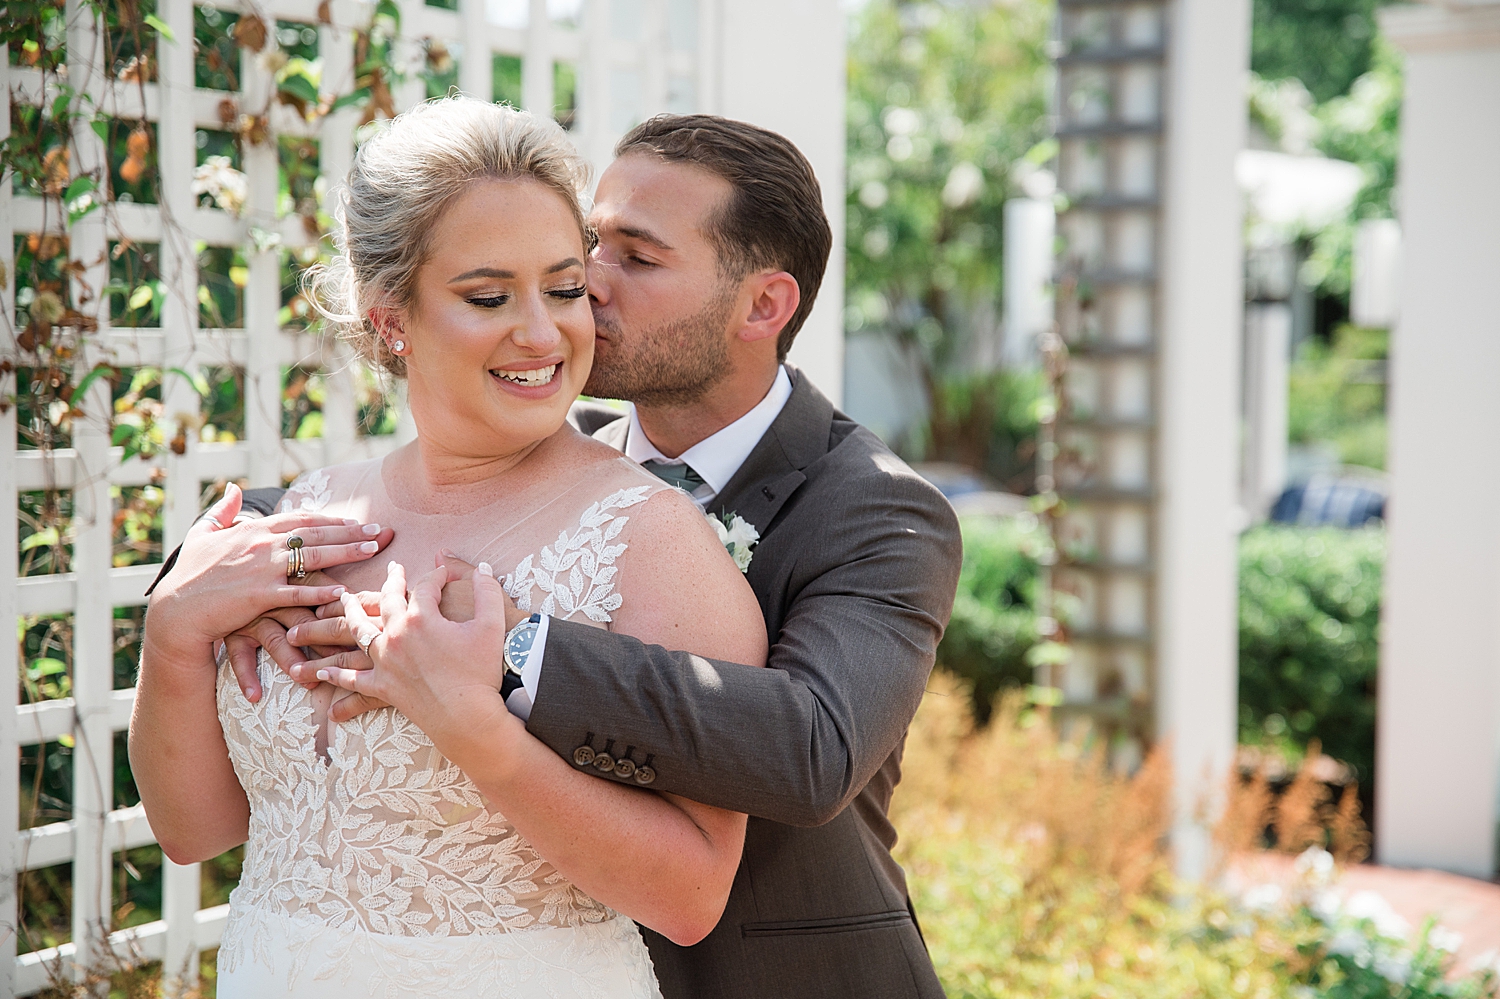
[584,153,749,405]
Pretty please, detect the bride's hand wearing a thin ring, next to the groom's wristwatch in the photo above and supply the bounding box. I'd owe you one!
[313,563,521,759]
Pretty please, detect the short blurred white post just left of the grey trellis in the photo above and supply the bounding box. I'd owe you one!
[1001,198,1058,368]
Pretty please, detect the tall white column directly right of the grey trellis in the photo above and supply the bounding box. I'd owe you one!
[1152,0,1250,875]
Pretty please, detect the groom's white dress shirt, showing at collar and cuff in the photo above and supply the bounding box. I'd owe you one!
[506,366,792,720]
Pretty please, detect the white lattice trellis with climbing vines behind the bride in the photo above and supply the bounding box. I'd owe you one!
[0,0,720,995]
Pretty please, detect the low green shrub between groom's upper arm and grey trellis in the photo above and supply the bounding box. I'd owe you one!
[938,515,1052,723]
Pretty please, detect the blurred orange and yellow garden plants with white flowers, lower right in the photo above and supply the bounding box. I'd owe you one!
[893,675,1496,999]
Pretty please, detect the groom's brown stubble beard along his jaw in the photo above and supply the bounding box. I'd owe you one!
[584,281,740,407]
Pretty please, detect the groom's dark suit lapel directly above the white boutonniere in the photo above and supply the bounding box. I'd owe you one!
[710,368,834,537]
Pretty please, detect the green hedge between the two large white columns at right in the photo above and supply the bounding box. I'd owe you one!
[1239,525,1386,786]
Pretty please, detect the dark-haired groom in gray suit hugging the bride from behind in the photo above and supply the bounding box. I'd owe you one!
[219,116,962,999]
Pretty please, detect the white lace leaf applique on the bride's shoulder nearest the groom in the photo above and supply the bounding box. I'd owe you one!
[504,486,653,624]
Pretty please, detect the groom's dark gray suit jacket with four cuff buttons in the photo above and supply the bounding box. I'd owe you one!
[543,372,962,999]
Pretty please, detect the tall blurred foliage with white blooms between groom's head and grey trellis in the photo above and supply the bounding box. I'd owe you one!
[845,0,1052,480]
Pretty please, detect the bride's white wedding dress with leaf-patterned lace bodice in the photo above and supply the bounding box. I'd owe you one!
[218,459,665,999]
